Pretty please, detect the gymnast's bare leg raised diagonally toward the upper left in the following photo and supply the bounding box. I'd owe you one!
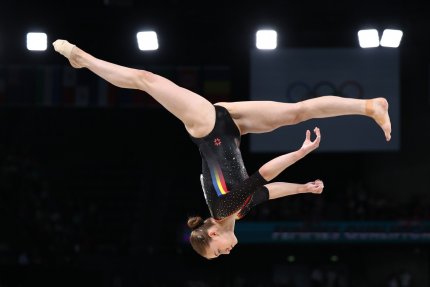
[53,40,215,137]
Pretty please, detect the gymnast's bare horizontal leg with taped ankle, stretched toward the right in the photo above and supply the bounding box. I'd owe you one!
[217,96,391,141]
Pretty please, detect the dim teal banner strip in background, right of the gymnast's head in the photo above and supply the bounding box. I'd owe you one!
[236,221,430,243]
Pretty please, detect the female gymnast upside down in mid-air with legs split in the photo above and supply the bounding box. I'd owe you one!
[53,39,391,259]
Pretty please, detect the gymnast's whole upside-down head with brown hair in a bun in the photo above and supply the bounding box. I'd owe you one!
[188,216,237,259]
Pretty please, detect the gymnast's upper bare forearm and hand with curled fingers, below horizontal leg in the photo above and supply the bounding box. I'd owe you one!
[259,128,321,181]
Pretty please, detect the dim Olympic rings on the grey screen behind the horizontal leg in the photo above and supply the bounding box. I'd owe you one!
[285,81,364,103]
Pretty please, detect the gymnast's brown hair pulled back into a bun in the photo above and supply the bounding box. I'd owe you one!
[187,216,214,256]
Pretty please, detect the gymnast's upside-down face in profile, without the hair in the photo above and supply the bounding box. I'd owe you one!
[205,229,237,259]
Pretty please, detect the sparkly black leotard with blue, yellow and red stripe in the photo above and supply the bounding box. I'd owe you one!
[191,105,269,220]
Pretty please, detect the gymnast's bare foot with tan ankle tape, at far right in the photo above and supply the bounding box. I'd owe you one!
[366,98,391,141]
